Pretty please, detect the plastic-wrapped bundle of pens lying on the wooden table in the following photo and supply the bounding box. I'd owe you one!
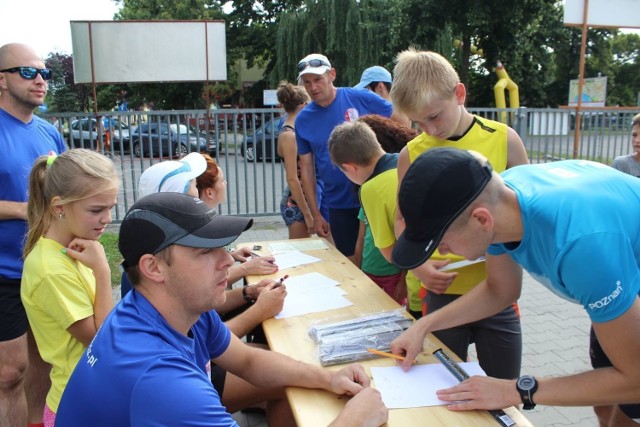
[309,309,413,366]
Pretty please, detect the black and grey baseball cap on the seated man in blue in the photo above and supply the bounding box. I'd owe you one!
[118,193,253,269]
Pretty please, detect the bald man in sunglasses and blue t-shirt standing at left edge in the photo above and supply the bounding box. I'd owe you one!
[0,43,66,427]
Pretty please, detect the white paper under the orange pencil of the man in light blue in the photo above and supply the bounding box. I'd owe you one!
[371,362,486,409]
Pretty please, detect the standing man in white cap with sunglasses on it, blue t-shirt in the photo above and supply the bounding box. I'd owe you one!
[295,53,395,260]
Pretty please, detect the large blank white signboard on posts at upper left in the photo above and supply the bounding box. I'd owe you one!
[71,21,227,83]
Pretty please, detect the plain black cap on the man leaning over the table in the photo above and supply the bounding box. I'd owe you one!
[392,148,493,270]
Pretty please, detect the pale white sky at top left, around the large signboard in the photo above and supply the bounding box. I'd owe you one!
[0,0,118,58]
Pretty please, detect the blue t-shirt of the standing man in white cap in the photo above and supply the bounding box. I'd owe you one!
[295,87,393,209]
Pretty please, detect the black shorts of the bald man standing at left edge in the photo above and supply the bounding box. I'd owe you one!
[0,277,29,341]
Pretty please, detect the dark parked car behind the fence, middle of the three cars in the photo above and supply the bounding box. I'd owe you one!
[131,123,217,158]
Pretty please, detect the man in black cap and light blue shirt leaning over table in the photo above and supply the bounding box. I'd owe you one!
[391,148,640,426]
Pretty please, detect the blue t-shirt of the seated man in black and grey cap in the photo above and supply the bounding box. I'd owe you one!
[56,290,237,427]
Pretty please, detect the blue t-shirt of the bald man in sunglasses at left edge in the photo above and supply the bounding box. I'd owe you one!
[0,109,67,279]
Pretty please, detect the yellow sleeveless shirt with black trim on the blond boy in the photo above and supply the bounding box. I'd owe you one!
[407,116,508,295]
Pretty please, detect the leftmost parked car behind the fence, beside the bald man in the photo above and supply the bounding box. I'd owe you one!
[69,117,130,151]
